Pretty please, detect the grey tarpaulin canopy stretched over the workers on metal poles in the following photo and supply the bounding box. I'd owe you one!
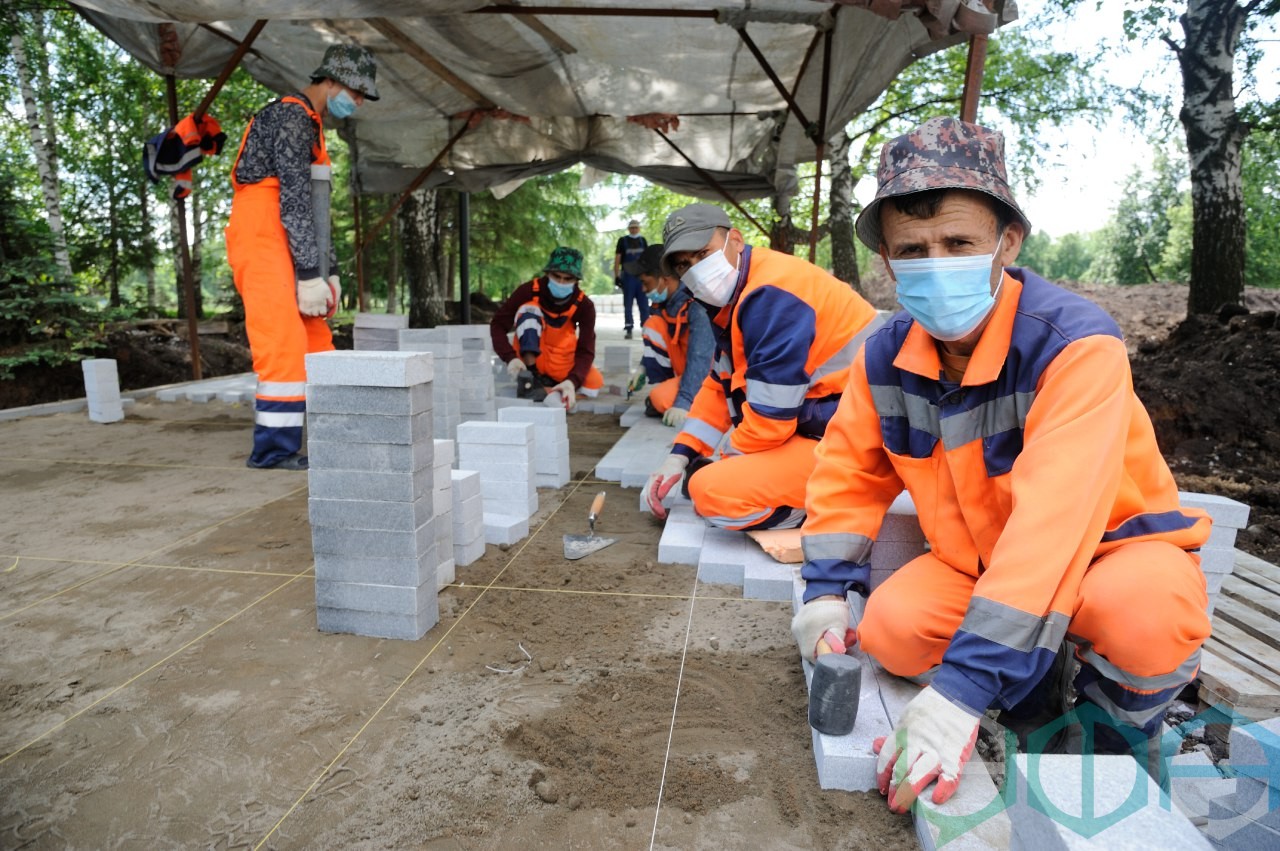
[73,0,1016,198]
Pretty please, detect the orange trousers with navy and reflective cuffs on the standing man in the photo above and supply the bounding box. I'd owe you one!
[227,183,333,467]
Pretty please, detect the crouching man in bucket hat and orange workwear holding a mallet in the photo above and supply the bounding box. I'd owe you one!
[792,118,1210,813]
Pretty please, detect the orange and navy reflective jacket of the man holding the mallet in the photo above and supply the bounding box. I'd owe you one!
[801,269,1210,712]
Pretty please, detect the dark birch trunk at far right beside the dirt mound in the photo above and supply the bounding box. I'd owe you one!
[1169,0,1256,315]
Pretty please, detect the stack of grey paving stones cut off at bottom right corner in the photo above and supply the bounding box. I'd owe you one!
[1204,718,1280,851]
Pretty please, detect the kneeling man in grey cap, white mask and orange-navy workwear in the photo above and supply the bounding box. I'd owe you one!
[644,203,879,530]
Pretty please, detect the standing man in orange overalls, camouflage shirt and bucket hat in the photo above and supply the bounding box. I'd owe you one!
[227,45,378,470]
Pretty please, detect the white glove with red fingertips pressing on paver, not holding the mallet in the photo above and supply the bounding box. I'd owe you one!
[872,686,980,813]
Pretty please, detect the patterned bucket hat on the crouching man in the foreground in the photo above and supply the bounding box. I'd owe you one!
[854,118,1032,251]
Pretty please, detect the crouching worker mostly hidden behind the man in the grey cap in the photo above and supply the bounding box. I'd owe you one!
[628,244,716,429]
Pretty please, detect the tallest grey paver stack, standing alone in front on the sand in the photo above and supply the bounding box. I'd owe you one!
[306,352,439,640]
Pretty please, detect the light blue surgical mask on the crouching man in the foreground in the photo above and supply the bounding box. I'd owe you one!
[888,234,1004,342]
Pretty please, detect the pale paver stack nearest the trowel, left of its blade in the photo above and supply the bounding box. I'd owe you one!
[458,422,538,545]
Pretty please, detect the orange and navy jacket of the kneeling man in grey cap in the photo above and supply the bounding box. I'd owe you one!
[672,246,879,458]
